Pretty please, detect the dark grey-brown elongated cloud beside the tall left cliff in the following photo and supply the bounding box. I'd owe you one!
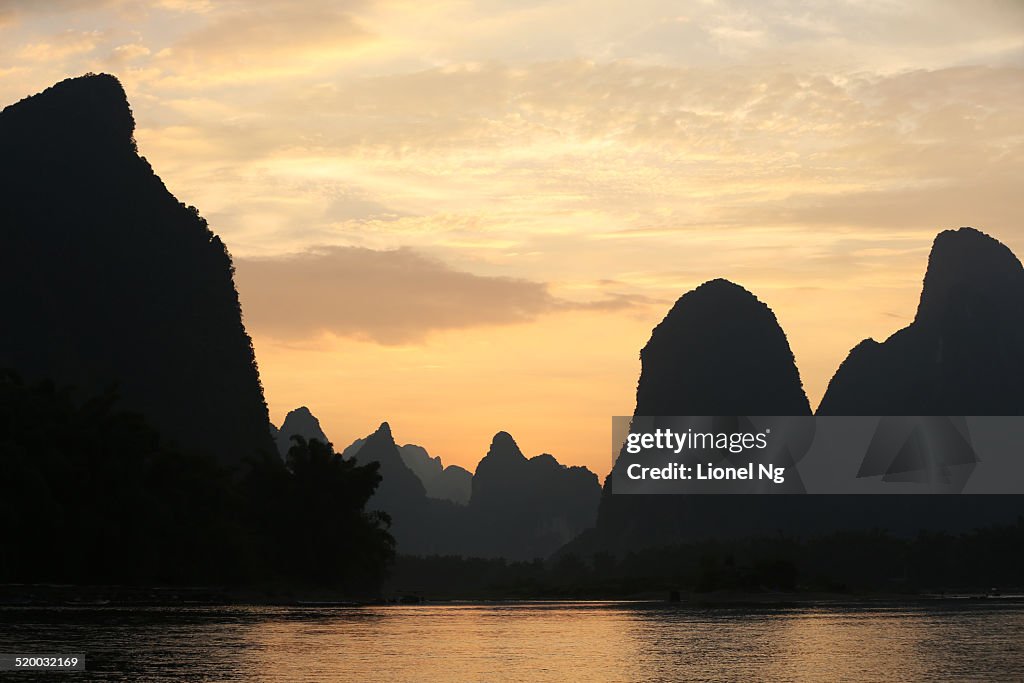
[236,247,650,345]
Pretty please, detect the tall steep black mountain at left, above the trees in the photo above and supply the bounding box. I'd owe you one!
[0,75,274,463]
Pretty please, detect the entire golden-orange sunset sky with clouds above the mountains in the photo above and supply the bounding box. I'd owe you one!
[0,0,1024,477]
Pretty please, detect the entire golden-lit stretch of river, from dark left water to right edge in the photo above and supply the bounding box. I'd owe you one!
[234,603,1024,682]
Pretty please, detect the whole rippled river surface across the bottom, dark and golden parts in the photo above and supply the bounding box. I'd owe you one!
[0,600,1024,683]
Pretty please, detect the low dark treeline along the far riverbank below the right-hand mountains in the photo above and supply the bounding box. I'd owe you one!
[389,519,1024,599]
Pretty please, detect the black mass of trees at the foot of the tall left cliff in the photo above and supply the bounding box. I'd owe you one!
[0,371,394,593]
